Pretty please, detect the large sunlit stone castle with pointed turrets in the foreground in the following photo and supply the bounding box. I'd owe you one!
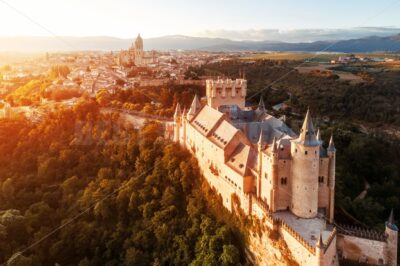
[169,79,398,266]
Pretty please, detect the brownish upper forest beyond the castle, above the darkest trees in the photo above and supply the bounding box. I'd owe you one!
[186,60,400,126]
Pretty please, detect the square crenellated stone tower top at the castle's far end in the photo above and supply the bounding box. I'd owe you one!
[206,79,247,110]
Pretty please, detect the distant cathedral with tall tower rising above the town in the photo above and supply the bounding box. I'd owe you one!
[117,34,156,67]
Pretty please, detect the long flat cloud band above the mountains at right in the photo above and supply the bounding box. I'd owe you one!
[194,27,400,42]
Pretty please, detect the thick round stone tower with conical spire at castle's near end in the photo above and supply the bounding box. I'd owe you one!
[291,110,321,218]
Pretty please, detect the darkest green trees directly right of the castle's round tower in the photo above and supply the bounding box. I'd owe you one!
[322,124,400,229]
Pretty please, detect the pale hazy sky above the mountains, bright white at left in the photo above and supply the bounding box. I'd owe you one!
[0,0,400,39]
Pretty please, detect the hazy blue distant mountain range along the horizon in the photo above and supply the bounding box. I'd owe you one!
[0,34,400,52]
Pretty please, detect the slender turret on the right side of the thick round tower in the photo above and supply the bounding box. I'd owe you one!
[327,135,336,223]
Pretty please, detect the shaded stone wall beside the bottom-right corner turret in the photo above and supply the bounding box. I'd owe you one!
[337,234,387,265]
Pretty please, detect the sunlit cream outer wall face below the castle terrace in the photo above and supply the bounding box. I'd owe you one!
[279,226,317,266]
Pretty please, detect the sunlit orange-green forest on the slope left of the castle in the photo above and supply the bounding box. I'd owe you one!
[0,101,245,266]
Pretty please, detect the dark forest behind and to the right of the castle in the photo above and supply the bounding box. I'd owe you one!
[186,60,400,230]
